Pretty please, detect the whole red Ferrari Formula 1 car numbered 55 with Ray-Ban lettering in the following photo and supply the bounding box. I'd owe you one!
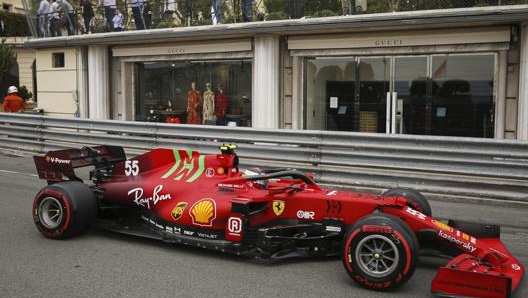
[33,145,525,298]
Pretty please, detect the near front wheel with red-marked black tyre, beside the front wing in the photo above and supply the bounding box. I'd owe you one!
[342,213,419,291]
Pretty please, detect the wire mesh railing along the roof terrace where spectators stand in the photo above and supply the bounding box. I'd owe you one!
[22,0,528,37]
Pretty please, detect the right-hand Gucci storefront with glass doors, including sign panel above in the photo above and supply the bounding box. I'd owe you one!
[289,27,510,138]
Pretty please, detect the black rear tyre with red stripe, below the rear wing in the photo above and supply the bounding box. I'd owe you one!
[33,181,97,239]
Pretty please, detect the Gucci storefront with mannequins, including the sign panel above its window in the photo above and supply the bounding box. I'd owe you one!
[113,40,252,126]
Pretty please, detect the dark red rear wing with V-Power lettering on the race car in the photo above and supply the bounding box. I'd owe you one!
[33,146,126,182]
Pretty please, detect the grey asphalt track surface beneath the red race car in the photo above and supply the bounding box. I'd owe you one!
[0,153,528,298]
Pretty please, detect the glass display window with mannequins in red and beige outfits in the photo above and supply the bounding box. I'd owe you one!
[135,60,252,127]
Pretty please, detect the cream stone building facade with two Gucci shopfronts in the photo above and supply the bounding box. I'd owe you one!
[25,5,528,140]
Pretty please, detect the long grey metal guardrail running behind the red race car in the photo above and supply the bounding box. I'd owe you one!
[0,113,528,203]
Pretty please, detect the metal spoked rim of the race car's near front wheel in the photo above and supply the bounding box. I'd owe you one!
[355,235,400,277]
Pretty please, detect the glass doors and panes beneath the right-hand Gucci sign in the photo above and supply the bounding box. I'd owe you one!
[306,53,496,137]
